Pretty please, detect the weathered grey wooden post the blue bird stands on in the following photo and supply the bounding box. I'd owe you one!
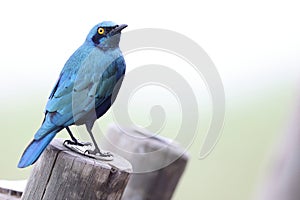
[22,139,132,200]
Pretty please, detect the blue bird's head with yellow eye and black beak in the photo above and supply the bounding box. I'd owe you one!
[86,21,127,50]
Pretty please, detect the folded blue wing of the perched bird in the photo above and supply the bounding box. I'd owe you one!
[35,47,123,139]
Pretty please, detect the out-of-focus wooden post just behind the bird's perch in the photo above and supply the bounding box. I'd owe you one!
[101,126,188,200]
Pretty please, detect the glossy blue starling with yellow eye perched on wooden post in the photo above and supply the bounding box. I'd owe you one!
[18,21,127,168]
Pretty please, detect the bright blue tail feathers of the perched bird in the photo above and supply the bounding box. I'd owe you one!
[18,131,57,168]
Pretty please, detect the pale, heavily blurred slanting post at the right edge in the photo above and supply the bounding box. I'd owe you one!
[254,93,300,200]
